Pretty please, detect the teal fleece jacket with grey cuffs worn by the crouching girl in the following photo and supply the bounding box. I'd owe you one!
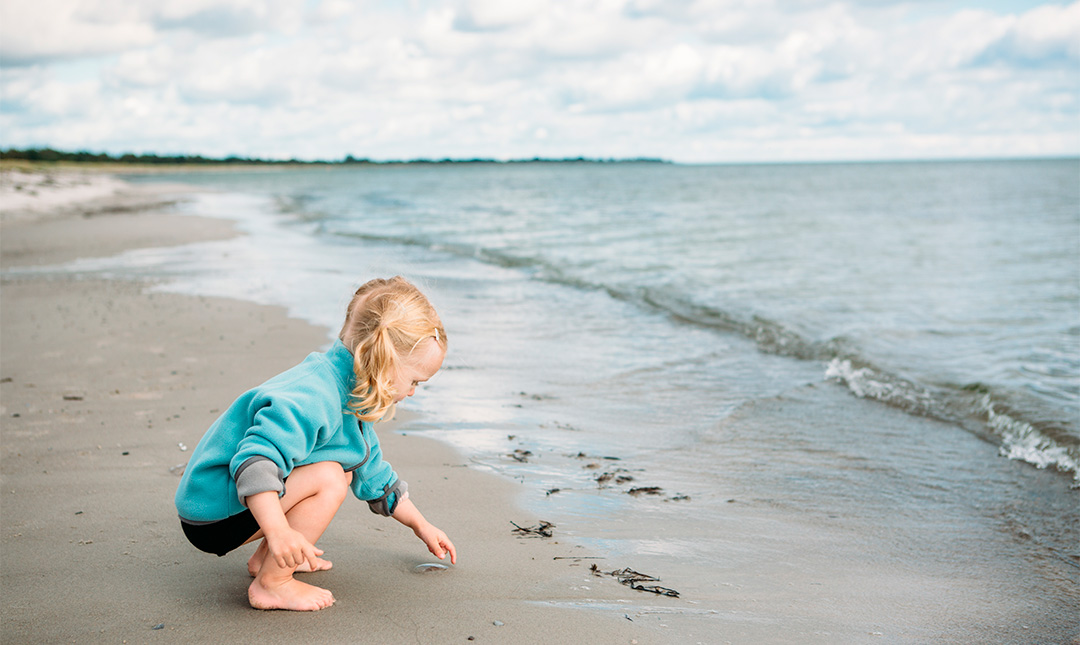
[176,340,407,524]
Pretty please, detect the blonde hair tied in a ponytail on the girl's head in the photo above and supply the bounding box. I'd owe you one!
[338,276,446,421]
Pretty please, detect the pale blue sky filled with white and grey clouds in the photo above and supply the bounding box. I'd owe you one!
[0,0,1080,163]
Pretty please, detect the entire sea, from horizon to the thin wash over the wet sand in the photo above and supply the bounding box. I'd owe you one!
[65,159,1080,642]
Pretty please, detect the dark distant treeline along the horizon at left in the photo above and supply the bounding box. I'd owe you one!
[0,148,671,165]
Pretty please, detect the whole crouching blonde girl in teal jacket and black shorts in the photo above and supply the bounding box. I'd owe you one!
[176,277,457,612]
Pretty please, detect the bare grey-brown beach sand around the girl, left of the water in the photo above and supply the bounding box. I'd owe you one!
[0,179,656,644]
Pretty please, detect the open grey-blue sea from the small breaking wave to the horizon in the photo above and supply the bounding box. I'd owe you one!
[126,160,1080,472]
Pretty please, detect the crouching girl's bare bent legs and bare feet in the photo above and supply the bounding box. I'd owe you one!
[247,461,351,612]
